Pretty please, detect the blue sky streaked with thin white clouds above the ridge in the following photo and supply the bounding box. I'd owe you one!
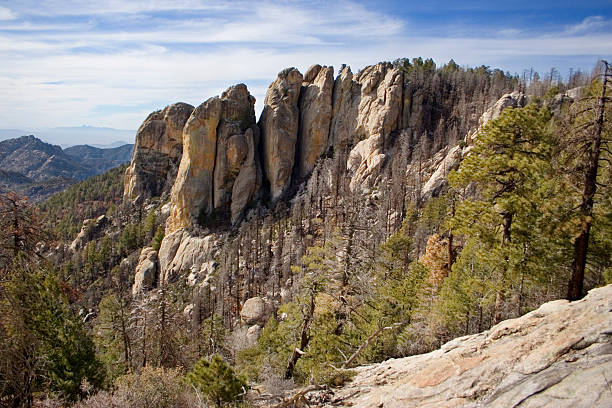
[0,0,612,143]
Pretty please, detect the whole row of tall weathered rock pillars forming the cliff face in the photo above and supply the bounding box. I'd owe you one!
[124,63,524,290]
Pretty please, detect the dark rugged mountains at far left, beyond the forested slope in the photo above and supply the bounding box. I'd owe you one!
[0,135,133,202]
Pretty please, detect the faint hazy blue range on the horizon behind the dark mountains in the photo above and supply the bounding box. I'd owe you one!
[0,126,136,148]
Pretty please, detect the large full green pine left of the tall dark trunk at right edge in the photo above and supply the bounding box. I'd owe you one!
[450,105,555,322]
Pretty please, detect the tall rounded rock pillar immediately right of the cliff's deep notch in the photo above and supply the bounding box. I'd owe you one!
[259,68,303,200]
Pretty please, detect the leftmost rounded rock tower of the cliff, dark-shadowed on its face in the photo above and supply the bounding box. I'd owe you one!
[123,102,193,199]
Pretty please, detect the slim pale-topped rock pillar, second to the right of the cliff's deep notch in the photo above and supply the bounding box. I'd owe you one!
[296,65,334,179]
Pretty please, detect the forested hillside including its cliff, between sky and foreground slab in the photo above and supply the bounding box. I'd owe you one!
[0,58,612,407]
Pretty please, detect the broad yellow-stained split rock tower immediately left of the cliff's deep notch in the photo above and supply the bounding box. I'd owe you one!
[166,84,260,233]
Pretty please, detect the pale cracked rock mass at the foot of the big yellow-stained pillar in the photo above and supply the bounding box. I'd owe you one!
[158,229,218,283]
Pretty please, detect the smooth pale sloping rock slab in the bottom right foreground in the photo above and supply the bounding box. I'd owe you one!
[326,285,612,408]
